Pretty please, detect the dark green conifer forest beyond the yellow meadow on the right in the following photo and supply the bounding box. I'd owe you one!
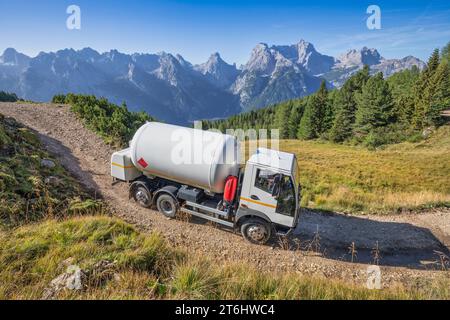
[203,43,450,147]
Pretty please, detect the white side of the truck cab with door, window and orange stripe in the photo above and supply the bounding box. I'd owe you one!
[241,166,295,227]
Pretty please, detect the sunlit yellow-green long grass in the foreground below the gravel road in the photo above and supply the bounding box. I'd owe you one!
[0,216,450,299]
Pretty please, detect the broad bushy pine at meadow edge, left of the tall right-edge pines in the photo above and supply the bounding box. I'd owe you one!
[354,72,394,137]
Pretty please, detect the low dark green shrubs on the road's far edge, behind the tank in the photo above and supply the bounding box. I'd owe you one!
[52,93,153,147]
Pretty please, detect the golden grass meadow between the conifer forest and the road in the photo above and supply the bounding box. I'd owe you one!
[248,125,450,214]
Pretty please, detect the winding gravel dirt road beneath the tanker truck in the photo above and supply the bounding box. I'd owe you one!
[0,103,450,285]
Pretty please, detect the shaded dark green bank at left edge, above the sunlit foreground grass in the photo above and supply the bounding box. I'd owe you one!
[0,114,102,226]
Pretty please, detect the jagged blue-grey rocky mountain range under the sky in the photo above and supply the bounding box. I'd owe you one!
[0,40,425,123]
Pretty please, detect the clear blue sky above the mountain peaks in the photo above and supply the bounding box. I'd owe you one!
[0,0,450,65]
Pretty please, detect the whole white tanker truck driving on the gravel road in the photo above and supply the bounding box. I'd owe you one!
[111,122,300,244]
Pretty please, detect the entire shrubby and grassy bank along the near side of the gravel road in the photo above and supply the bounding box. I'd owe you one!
[0,111,450,299]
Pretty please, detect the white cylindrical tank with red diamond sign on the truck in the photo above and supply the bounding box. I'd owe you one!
[130,122,240,193]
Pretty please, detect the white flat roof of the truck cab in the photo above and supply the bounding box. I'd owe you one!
[248,148,296,173]
